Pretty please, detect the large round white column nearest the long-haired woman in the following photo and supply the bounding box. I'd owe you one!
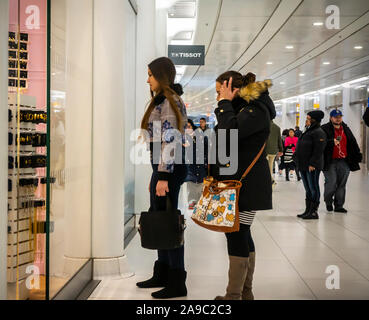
[92,0,134,279]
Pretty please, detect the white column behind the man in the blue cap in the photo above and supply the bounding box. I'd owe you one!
[342,85,362,141]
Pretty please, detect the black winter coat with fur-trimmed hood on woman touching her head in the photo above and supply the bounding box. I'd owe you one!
[211,81,275,211]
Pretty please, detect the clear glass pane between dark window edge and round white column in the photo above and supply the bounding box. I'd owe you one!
[49,0,93,299]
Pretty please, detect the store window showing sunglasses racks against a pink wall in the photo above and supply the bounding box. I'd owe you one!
[7,0,47,300]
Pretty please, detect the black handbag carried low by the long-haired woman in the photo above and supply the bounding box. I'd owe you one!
[138,196,186,250]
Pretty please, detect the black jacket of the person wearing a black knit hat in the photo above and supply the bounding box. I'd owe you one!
[293,123,327,171]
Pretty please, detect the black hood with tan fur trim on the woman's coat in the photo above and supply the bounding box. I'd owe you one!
[239,80,277,120]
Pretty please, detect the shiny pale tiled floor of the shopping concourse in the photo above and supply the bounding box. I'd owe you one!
[90,172,369,300]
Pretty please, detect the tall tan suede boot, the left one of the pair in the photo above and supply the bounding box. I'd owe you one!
[215,256,249,300]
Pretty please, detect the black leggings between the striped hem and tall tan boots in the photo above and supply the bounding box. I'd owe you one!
[225,224,255,258]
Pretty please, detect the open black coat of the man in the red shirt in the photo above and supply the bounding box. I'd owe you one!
[322,122,363,171]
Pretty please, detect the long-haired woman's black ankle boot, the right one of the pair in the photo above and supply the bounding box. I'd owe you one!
[151,269,187,299]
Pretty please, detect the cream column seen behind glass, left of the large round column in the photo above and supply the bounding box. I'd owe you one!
[61,0,93,274]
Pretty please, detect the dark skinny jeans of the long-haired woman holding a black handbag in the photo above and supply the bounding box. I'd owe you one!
[150,164,187,270]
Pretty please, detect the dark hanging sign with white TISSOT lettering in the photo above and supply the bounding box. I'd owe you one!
[168,45,205,66]
